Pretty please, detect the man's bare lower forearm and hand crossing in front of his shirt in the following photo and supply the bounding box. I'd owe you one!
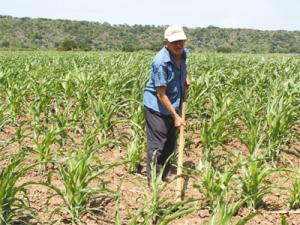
[157,86,184,127]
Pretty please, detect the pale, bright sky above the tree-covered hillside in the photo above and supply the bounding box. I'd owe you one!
[0,0,300,31]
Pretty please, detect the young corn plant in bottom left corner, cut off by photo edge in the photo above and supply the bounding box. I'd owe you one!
[0,151,36,224]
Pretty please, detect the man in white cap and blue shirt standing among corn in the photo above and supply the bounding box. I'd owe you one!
[144,26,189,181]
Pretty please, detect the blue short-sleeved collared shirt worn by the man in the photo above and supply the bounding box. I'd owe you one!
[144,47,187,115]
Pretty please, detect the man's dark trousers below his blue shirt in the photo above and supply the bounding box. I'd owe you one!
[144,107,177,181]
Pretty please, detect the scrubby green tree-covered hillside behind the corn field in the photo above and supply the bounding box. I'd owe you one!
[0,15,300,53]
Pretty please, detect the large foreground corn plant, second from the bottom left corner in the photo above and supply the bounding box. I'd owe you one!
[36,134,123,223]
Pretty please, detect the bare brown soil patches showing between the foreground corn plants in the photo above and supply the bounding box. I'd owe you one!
[0,122,300,225]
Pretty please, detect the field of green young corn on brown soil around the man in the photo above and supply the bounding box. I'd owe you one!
[0,52,300,225]
